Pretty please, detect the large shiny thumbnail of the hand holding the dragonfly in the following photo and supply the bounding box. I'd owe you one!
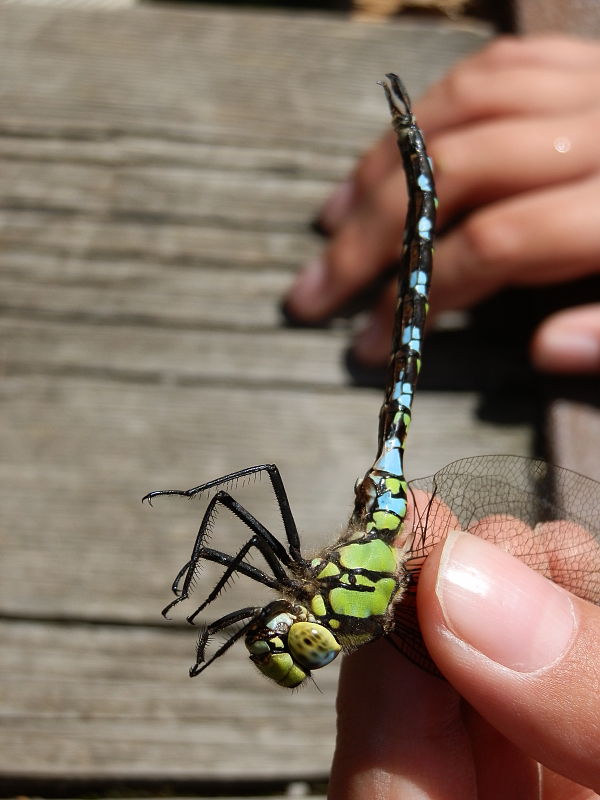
[436,531,575,672]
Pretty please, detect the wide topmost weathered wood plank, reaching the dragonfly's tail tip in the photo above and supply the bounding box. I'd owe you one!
[0,5,489,142]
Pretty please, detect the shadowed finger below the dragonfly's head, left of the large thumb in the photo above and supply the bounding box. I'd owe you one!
[329,640,477,800]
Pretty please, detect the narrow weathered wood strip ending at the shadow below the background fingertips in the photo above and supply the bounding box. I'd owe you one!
[0,316,348,389]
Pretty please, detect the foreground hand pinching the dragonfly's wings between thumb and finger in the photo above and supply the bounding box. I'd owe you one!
[330,523,600,800]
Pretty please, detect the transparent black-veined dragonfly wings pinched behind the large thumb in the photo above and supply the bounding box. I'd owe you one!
[393,456,600,673]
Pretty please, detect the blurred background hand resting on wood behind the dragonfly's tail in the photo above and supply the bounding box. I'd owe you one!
[285,36,600,372]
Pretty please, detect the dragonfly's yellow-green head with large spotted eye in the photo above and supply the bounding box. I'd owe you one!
[246,600,342,689]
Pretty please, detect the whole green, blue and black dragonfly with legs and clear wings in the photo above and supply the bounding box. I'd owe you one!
[143,73,600,688]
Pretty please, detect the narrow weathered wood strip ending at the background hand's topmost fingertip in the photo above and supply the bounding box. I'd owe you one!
[2,160,338,230]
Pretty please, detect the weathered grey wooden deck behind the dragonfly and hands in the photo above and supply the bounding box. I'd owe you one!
[0,3,548,797]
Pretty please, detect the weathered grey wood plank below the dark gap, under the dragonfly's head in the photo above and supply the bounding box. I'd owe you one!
[0,622,337,779]
